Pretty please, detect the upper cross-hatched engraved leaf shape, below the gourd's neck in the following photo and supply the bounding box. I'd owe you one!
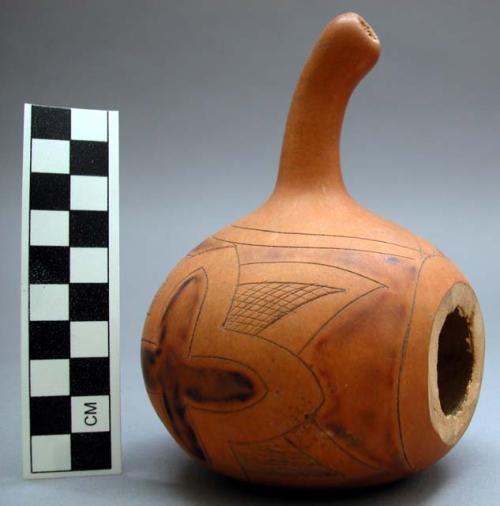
[224,281,344,335]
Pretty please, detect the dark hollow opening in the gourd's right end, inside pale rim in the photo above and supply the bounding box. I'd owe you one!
[437,307,474,415]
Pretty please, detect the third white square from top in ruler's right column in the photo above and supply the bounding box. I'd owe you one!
[69,248,108,283]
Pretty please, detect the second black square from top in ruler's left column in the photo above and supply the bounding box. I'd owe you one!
[30,172,70,211]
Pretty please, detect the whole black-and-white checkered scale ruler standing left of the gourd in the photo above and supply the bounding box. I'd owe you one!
[21,104,121,478]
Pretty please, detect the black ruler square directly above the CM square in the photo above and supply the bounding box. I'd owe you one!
[69,357,109,395]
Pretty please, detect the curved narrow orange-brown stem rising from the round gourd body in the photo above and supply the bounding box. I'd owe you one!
[274,13,380,195]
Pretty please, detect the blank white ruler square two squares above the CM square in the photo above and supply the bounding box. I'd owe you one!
[70,322,108,358]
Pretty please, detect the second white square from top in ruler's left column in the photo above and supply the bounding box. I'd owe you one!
[30,211,69,246]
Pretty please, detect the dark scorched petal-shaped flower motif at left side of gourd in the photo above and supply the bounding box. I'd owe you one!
[142,269,257,461]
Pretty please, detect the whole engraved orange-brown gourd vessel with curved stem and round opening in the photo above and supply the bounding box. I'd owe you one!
[142,13,484,487]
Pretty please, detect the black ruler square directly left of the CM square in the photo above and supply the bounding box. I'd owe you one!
[30,395,71,436]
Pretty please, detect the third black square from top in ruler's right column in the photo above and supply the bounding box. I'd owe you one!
[69,283,109,321]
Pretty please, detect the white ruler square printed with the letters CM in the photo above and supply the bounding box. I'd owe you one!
[71,395,109,432]
